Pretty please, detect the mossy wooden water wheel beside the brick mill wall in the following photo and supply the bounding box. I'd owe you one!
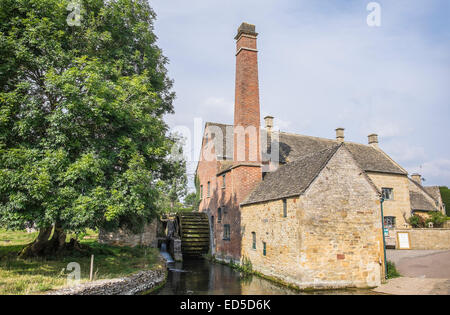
[177,212,210,256]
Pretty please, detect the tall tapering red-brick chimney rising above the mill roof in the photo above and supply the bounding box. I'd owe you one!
[234,23,261,163]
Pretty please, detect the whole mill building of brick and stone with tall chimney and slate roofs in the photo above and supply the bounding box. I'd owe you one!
[196,23,437,288]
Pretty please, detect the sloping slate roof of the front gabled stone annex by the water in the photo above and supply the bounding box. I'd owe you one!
[243,145,340,204]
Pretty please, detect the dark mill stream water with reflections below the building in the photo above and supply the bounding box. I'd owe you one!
[155,259,374,295]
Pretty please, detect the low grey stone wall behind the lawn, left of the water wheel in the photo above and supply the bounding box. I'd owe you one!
[98,219,158,247]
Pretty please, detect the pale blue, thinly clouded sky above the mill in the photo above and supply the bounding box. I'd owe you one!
[149,0,450,190]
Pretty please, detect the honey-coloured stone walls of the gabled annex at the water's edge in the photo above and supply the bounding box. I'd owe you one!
[242,149,384,289]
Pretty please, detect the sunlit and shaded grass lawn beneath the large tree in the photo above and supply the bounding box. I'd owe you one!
[0,230,161,295]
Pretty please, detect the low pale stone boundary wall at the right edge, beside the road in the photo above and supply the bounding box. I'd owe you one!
[395,229,450,250]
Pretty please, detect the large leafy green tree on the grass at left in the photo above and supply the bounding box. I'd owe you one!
[0,0,179,257]
